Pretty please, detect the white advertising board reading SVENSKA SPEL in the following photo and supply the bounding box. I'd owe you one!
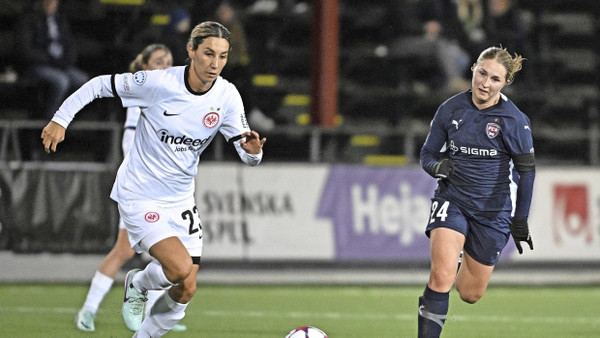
[196,163,334,260]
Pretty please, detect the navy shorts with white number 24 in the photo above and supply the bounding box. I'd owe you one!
[425,197,509,266]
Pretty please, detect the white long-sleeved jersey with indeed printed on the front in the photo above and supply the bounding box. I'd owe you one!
[52,66,262,202]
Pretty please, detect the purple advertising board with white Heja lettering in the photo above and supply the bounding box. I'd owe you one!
[318,166,436,261]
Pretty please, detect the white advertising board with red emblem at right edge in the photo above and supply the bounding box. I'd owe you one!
[512,168,600,261]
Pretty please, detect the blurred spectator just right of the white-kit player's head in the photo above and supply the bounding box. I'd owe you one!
[214,1,275,132]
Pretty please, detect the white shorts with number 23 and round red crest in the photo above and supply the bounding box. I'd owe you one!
[119,196,202,258]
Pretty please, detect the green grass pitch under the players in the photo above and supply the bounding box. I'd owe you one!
[0,284,600,338]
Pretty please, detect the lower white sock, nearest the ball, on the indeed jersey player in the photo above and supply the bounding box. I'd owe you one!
[136,292,189,337]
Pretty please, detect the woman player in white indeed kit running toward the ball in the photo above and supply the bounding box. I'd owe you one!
[41,21,266,337]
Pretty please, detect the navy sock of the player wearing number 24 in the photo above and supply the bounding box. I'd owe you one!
[418,286,450,338]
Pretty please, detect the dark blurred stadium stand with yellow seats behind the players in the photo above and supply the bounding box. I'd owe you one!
[0,0,600,164]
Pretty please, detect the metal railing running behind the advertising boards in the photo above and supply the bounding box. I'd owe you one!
[0,117,600,166]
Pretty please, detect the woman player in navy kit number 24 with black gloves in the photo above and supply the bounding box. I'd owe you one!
[418,47,535,337]
